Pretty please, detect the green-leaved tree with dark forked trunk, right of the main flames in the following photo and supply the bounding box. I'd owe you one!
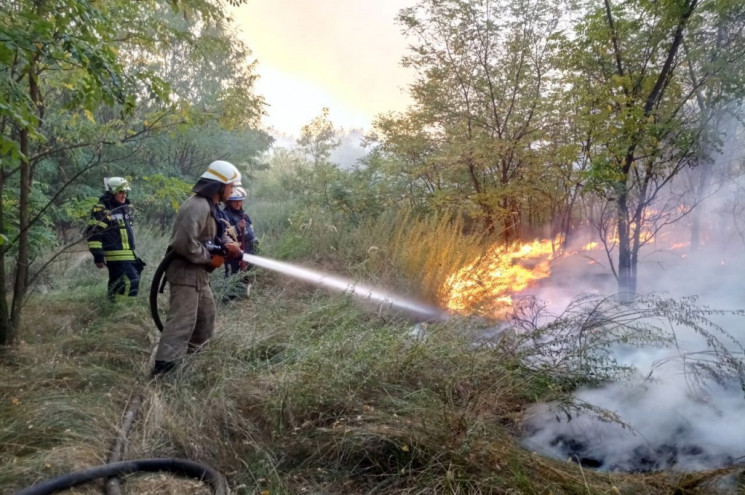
[565,0,745,302]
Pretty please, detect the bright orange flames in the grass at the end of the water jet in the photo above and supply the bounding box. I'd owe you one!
[440,239,556,316]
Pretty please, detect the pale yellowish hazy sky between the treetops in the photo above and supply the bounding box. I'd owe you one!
[233,0,413,135]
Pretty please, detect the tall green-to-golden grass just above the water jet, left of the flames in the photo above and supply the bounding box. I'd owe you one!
[253,206,486,304]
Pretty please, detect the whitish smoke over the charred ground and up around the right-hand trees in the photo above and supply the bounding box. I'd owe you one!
[522,127,745,472]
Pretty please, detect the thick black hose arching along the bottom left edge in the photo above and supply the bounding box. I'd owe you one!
[15,459,228,495]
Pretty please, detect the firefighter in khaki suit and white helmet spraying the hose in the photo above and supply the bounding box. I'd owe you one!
[152,160,243,376]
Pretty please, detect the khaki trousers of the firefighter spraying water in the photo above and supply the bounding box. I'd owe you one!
[155,283,216,362]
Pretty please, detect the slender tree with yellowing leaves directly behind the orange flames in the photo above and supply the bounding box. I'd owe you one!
[388,0,559,241]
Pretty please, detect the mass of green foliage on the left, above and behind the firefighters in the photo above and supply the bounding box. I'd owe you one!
[0,0,271,343]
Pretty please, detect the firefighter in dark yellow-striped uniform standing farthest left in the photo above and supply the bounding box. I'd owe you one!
[85,177,145,301]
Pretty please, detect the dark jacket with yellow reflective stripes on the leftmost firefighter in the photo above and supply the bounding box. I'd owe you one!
[85,192,136,263]
